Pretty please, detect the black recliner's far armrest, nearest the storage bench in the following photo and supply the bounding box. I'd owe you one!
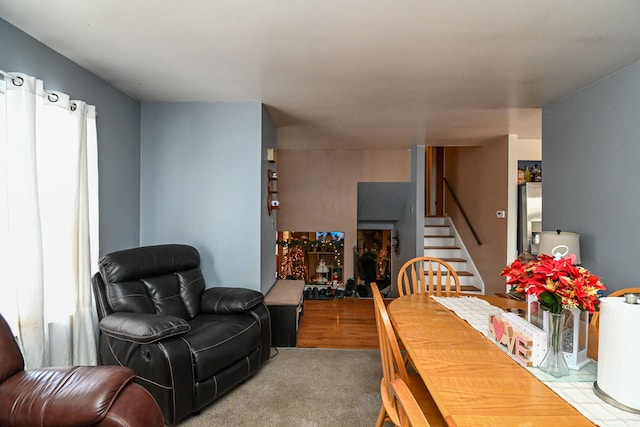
[200,288,264,314]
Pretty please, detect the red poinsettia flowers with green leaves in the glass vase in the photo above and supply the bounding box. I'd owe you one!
[501,254,606,313]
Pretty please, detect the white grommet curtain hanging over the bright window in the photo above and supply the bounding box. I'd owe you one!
[0,72,98,368]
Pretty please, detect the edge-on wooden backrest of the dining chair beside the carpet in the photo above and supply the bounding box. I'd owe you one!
[371,282,409,425]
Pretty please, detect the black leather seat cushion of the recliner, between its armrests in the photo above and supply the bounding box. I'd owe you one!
[186,313,261,380]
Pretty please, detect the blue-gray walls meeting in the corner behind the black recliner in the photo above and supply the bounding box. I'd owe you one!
[0,19,276,292]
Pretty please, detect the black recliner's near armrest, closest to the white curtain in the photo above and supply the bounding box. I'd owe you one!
[100,313,191,344]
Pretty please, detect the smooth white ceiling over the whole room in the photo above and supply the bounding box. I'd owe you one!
[0,0,640,149]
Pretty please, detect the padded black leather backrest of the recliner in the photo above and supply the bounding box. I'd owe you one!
[94,244,205,320]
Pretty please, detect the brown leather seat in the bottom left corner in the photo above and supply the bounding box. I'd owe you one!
[0,315,164,427]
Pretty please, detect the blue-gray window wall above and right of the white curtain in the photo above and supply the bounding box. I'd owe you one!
[0,19,140,254]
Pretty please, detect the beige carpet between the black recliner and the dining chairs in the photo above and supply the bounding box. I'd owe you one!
[179,348,382,427]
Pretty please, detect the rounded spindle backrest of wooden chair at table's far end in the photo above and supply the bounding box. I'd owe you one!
[398,256,460,296]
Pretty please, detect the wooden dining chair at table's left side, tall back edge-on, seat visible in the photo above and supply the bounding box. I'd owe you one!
[371,283,446,427]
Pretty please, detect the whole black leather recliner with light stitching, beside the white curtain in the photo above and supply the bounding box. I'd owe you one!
[92,244,271,424]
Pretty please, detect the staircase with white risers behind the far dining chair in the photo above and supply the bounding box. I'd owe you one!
[424,217,484,294]
